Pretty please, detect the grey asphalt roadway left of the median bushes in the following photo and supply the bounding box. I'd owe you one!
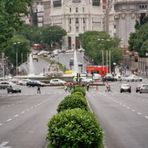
[0,87,67,148]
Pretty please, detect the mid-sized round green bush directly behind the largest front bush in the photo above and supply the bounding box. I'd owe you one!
[57,94,88,112]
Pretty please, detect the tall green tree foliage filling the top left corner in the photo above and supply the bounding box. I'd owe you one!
[0,0,31,52]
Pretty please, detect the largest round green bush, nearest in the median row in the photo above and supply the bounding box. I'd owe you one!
[47,108,103,148]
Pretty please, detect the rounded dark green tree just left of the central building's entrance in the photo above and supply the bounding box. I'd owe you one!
[42,26,66,49]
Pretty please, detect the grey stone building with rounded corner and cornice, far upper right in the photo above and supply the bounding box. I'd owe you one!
[114,0,148,48]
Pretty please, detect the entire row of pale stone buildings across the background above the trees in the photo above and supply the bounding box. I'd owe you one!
[32,0,148,49]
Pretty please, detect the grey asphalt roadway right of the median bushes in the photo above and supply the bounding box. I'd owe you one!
[87,80,148,148]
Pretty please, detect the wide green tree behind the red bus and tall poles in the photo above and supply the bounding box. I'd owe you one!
[79,31,122,65]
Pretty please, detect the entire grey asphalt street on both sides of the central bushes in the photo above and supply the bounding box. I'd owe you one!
[0,79,148,148]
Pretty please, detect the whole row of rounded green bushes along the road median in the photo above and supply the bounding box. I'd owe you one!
[47,87,104,148]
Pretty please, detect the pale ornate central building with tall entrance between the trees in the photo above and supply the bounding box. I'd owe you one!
[50,0,104,49]
